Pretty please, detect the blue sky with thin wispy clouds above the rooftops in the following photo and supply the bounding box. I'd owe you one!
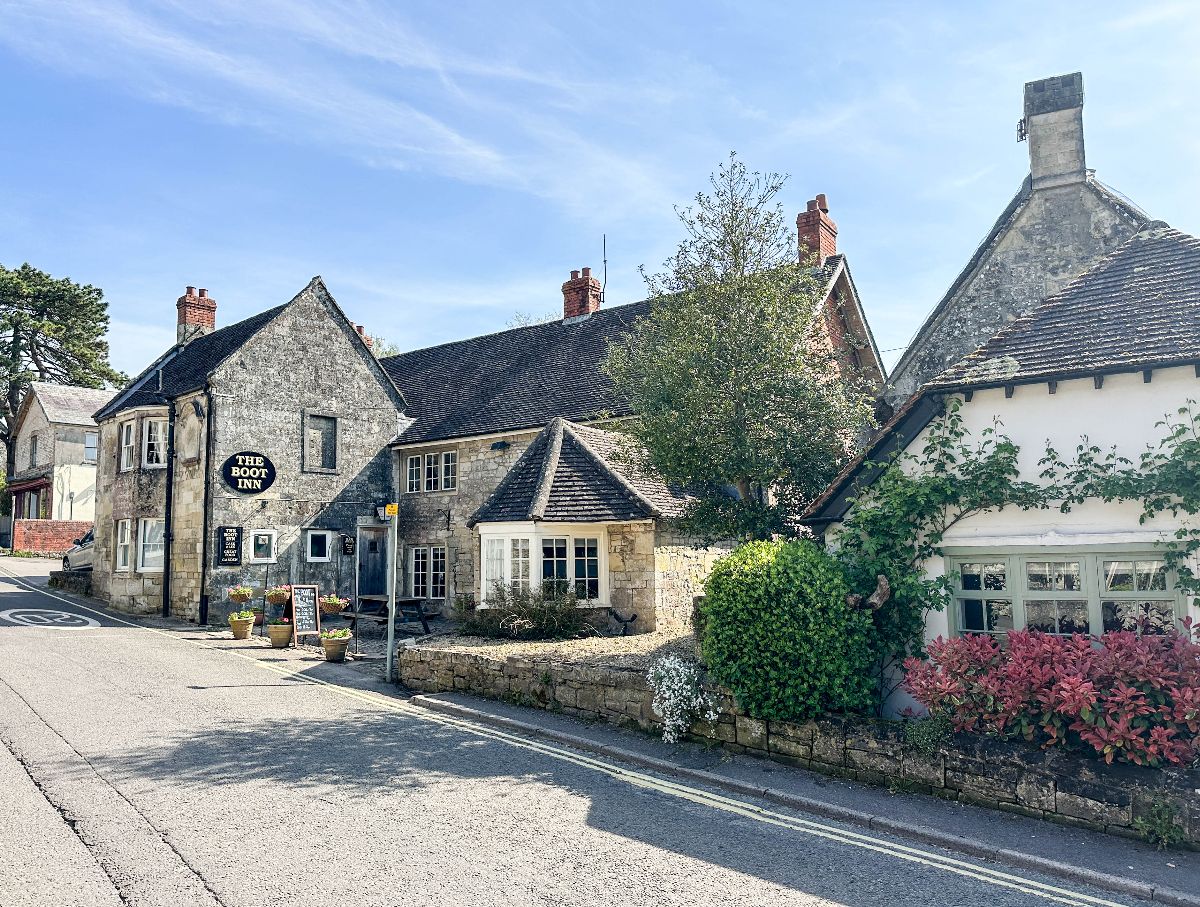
[0,0,1200,372]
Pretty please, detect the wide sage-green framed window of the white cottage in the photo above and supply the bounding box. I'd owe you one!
[948,549,1182,636]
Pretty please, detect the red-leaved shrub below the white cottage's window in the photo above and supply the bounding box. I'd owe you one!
[905,624,1200,765]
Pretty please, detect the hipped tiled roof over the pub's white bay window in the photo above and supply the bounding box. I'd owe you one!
[468,419,688,525]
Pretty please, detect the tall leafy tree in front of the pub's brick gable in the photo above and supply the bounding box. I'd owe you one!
[606,155,871,536]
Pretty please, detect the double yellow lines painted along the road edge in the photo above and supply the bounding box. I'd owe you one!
[0,565,1127,907]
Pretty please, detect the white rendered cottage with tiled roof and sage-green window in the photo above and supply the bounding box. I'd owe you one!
[806,221,1200,671]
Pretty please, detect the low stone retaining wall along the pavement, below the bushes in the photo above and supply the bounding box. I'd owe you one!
[398,647,1200,849]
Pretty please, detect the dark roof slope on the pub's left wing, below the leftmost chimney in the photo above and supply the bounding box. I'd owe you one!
[96,306,284,421]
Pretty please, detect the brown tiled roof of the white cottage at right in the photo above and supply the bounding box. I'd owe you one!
[929,221,1200,389]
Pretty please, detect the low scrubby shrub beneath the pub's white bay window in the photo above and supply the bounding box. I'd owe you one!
[454,585,598,639]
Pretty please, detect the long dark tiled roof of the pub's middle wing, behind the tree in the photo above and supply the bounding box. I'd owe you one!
[380,301,649,444]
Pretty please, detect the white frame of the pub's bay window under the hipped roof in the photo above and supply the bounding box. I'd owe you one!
[479,523,610,607]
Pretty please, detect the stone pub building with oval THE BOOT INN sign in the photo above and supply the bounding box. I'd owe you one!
[92,203,883,631]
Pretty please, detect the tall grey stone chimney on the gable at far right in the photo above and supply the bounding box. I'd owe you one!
[1022,72,1087,188]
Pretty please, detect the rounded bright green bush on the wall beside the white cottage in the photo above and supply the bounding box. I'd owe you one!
[701,541,875,721]
